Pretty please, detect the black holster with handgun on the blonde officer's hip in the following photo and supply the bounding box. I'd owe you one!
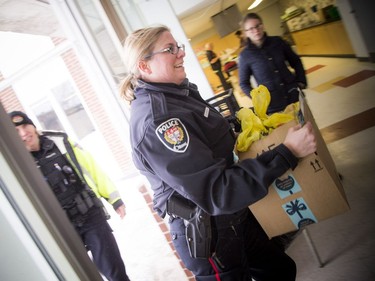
[167,193,212,259]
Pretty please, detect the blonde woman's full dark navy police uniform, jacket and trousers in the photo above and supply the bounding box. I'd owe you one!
[130,79,298,281]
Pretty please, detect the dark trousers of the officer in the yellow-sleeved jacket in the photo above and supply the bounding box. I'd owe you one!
[76,208,129,281]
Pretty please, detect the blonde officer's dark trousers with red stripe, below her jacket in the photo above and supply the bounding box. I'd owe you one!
[170,207,296,281]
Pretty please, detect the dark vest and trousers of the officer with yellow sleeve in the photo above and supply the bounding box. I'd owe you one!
[32,133,129,281]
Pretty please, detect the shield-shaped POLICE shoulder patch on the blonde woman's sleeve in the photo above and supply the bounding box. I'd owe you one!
[155,118,189,153]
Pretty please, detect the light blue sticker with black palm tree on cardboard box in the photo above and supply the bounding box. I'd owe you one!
[282,197,318,229]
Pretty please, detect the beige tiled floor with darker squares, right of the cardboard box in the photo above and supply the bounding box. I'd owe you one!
[288,55,375,281]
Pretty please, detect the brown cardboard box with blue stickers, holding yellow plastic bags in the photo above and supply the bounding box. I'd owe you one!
[239,95,349,237]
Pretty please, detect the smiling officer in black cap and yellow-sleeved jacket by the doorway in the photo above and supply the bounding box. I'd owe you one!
[9,111,130,281]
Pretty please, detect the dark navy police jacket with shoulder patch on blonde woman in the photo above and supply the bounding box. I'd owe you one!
[130,79,297,216]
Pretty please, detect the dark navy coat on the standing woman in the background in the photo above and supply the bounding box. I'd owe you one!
[239,34,307,112]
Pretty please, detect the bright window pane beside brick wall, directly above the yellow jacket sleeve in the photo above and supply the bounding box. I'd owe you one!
[51,81,95,139]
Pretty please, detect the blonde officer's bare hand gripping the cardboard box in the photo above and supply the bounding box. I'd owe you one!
[284,122,316,158]
